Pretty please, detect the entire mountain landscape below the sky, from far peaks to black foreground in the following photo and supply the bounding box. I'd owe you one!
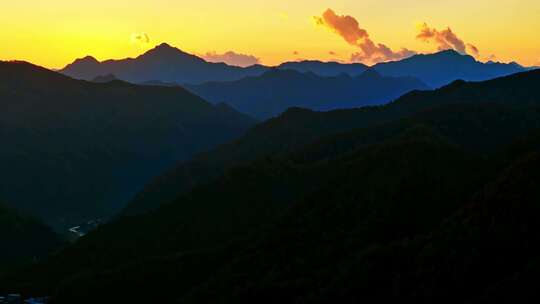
[0,38,540,304]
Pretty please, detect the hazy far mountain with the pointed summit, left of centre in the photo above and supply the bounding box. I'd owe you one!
[59,43,267,84]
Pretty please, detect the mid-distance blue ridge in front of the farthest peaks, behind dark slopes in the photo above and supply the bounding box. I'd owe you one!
[186,69,427,119]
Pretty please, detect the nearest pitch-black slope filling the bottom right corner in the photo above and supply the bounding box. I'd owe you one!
[314,150,540,303]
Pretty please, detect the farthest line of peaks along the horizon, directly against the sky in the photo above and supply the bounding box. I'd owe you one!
[60,43,526,88]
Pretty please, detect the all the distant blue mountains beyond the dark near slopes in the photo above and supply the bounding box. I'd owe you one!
[60,43,527,119]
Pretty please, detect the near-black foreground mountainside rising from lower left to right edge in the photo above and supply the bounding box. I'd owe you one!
[4,71,540,303]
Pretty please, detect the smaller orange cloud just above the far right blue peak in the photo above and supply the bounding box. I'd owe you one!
[416,23,480,56]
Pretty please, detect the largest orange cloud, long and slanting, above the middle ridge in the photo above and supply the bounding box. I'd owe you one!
[313,9,416,63]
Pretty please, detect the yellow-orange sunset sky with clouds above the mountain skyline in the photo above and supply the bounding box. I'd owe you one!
[0,0,540,68]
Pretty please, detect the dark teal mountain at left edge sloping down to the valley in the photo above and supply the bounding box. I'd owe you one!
[0,62,255,229]
